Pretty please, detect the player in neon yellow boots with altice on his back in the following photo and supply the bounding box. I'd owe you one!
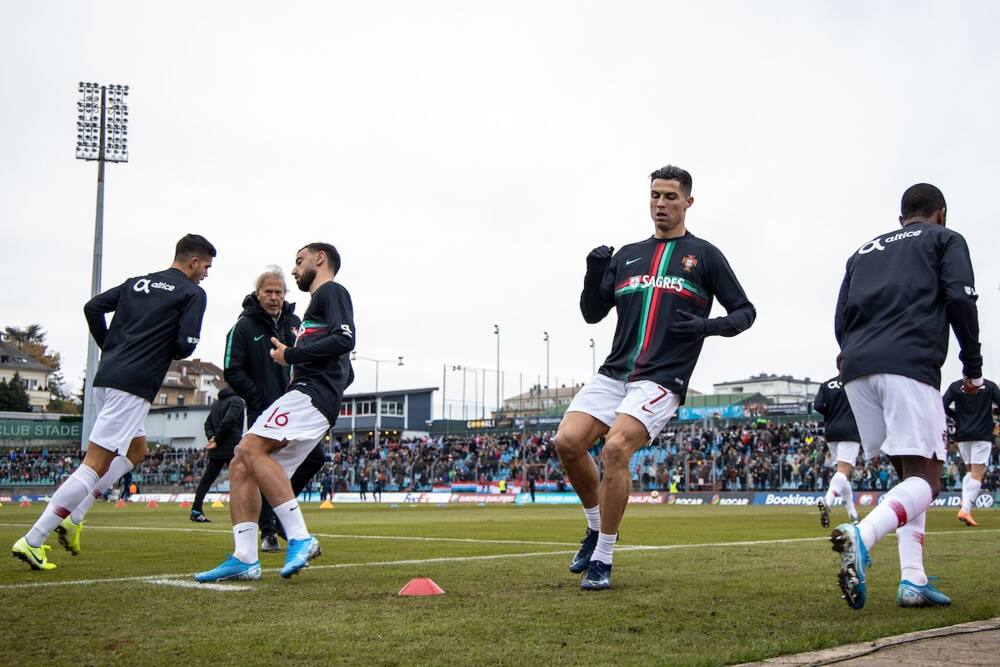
[12,234,215,570]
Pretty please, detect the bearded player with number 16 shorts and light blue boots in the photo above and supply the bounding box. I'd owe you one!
[195,243,354,582]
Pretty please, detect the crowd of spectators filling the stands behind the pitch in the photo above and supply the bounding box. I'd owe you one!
[0,422,1000,496]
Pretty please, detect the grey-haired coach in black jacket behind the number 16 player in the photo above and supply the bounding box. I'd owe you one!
[223,266,326,551]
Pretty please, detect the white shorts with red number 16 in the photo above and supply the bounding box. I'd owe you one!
[247,391,330,477]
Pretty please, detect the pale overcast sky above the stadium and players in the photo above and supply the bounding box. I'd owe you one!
[0,0,1000,416]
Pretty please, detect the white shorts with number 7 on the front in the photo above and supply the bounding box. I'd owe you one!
[566,373,681,440]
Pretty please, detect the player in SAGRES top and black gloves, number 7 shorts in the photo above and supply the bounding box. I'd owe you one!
[556,166,756,590]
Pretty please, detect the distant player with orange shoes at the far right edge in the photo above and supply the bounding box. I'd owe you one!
[942,380,1000,527]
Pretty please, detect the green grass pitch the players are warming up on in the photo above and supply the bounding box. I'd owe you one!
[0,504,1000,665]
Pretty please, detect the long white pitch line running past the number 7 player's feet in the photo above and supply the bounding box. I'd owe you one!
[0,528,1000,590]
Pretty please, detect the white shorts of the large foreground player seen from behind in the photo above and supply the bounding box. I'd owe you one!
[844,373,948,461]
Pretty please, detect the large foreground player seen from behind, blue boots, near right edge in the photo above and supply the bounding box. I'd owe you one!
[830,183,983,609]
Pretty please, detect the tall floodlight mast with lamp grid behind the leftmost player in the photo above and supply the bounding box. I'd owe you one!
[76,81,128,449]
